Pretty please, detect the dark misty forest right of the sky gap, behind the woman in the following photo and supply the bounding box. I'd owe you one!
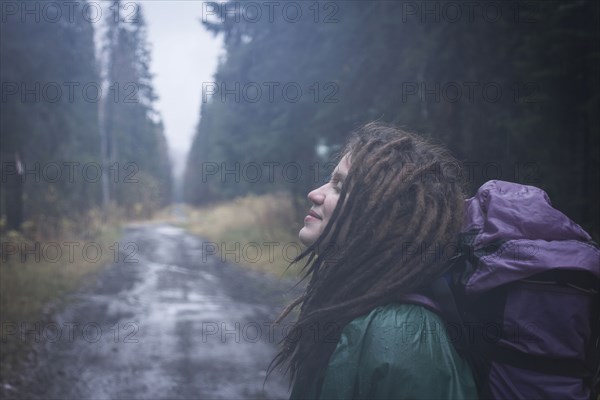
[183,0,600,239]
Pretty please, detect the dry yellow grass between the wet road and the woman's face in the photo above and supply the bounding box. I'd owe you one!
[183,193,302,276]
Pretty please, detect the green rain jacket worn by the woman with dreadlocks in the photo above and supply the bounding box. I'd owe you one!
[290,304,477,400]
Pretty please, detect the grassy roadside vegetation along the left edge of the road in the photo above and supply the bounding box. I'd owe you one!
[0,209,124,388]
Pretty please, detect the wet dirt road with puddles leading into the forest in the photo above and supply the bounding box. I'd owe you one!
[4,224,296,399]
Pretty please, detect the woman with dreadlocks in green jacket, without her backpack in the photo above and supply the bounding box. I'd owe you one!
[270,123,476,399]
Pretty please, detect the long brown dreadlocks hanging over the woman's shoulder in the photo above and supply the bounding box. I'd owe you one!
[269,123,464,388]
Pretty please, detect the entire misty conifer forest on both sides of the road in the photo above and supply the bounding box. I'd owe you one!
[0,0,600,238]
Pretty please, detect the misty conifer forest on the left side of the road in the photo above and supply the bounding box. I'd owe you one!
[0,1,173,238]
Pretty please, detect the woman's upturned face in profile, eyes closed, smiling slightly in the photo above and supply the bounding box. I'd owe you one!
[298,154,350,246]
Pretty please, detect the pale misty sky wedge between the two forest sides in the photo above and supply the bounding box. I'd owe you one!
[138,0,222,176]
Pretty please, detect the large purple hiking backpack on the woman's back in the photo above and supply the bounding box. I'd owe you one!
[408,181,600,400]
